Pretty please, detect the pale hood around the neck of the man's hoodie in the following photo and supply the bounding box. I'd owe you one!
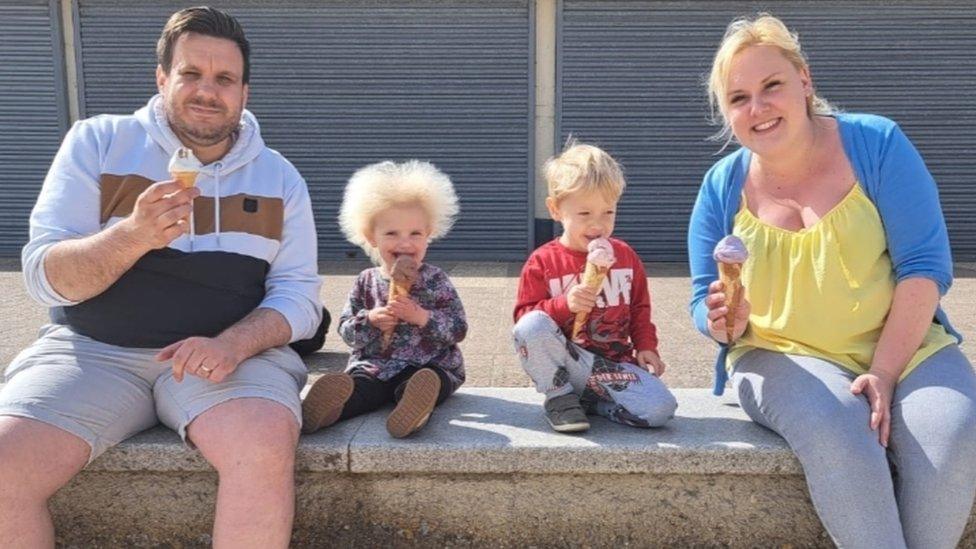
[134,94,264,176]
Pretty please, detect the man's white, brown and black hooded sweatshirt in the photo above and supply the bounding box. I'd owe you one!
[22,96,322,348]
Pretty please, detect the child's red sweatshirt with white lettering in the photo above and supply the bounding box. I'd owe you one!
[514,238,657,363]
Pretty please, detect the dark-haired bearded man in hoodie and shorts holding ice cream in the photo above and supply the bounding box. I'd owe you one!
[0,8,322,547]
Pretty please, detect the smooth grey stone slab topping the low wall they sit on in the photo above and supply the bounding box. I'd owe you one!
[87,387,802,475]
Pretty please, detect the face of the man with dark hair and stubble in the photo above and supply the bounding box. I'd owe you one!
[156,33,248,147]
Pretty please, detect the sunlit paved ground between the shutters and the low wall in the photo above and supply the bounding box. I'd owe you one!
[0,261,976,387]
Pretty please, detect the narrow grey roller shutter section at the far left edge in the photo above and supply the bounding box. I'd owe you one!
[0,0,68,257]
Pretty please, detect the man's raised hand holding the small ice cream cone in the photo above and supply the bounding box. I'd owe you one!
[119,180,200,250]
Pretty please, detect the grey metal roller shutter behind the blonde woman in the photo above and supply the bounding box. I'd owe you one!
[558,0,976,261]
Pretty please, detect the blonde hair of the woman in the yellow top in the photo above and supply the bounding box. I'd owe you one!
[708,13,835,144]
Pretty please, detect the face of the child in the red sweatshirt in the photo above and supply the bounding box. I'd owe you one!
[546,190,617,252]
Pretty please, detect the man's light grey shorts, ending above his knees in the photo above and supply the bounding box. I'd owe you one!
[0,325,308,461]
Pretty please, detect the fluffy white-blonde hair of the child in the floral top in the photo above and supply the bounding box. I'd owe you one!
[339,160,460,263]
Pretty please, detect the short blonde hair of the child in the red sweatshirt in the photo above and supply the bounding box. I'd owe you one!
[542,140,627,205]
